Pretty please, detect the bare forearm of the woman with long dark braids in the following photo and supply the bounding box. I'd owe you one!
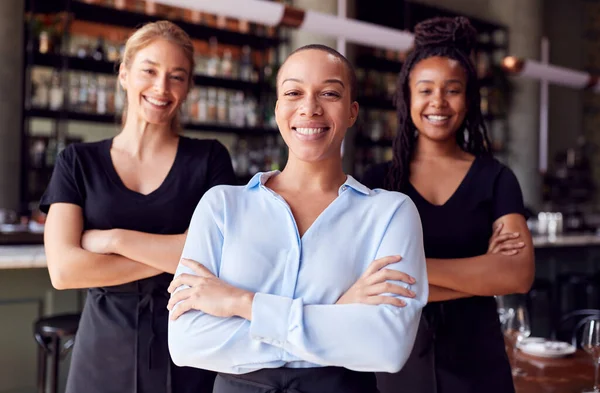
[427,250,535,296]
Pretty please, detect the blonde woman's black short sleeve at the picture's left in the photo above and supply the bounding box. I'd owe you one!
[40,145,85,213]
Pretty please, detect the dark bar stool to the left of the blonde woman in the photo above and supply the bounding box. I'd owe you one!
[33,314,81,393]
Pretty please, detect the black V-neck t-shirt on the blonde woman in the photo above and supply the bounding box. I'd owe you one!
[40,137,236,234]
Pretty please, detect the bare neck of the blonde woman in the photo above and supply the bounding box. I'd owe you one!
[113,116,179,159]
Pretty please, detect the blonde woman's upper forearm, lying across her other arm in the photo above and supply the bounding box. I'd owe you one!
[112,229,186,274]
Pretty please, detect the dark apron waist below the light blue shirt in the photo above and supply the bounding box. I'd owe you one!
[213,367,378,393]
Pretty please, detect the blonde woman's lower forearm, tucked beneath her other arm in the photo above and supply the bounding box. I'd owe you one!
[46,247,162,289]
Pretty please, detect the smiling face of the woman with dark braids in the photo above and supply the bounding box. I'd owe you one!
[409,56,467,142]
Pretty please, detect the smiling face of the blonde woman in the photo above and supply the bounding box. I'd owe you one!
[119,39,191,125]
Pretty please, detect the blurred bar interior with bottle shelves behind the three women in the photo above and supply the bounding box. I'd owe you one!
[0,0,600,393]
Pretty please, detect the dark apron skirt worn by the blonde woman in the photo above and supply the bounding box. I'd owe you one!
[66,274,216,393]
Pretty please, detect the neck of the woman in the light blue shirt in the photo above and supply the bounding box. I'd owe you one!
[276,154,347,192]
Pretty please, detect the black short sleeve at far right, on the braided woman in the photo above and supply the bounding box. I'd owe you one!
[492,167,525,221]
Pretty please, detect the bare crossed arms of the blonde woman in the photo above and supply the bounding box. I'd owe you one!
[44,203,185,289]
